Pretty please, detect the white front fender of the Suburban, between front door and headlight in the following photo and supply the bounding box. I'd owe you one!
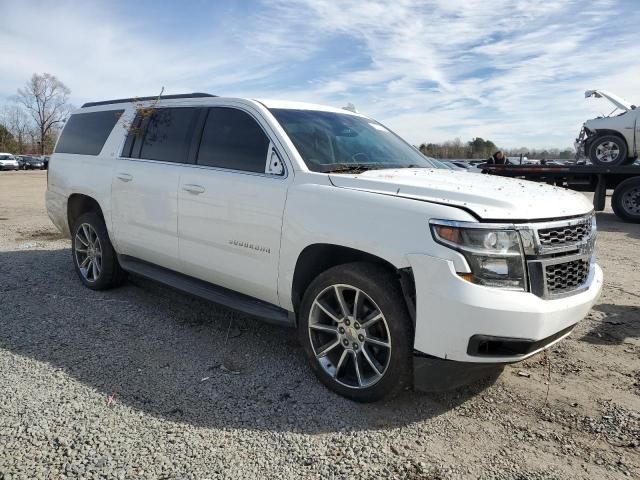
[278,184,474,311]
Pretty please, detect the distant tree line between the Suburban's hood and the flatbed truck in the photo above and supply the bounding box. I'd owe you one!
[418,137,575,160]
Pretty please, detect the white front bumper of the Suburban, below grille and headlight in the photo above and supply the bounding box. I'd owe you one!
[408,254,602,364]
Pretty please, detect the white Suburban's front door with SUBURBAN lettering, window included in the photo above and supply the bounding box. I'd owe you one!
[178,107,292,304]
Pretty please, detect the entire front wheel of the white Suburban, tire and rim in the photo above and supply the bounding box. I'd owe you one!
[298,263,413,402]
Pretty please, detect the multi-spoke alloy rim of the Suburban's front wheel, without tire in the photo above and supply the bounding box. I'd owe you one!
[308,284,391,389]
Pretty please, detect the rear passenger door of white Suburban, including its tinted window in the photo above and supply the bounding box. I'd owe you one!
[111,107,200,271]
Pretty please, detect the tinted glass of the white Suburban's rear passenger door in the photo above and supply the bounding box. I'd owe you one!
[140,108,197,163]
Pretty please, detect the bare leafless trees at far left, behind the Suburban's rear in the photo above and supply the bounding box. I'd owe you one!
[0,73,73,155]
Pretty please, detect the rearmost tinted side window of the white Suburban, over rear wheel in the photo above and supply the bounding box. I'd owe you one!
[56,110,124,155]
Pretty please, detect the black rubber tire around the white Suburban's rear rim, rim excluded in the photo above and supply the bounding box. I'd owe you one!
[71,212,127,290]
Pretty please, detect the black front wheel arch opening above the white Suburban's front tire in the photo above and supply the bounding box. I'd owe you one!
[291,243,416,324]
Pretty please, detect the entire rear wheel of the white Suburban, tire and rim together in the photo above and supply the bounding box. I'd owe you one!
[71,212,127,290]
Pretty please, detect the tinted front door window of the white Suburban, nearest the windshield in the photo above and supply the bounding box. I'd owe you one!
[197,108,269,173]
